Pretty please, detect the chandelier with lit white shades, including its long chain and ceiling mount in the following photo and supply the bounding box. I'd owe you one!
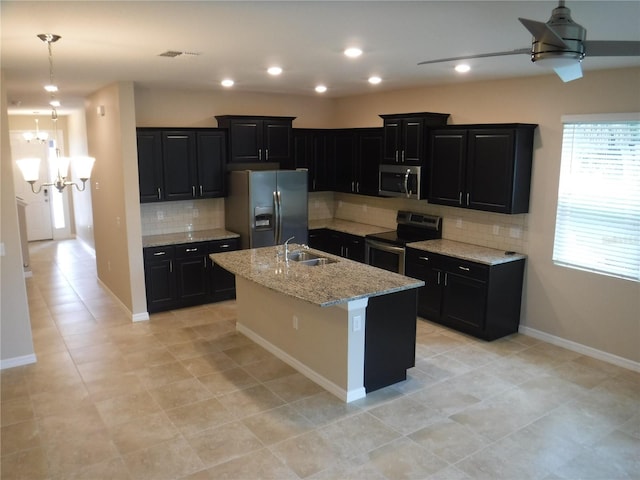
[16,33,96,193]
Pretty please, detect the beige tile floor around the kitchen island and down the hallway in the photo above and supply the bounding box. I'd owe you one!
[1,241,640,480]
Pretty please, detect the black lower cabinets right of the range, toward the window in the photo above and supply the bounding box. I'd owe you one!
[405,248,524,340]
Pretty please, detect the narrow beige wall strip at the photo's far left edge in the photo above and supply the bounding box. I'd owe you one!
[0,71,36,368]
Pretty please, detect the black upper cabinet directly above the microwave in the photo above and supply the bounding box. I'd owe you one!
[380,112,449,166]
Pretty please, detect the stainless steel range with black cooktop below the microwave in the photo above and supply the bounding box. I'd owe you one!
[364,210,442,275]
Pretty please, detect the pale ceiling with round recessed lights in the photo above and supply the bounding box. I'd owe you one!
[0,0,640,114]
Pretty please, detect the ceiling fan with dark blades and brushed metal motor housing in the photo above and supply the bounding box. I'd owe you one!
[418,0,640,82]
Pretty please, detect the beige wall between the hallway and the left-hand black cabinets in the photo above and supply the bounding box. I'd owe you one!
[85,82,147,319]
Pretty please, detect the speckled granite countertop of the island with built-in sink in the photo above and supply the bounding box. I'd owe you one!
[210,244,424,307]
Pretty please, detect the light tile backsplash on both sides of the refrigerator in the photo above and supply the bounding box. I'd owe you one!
[140,192,529,254]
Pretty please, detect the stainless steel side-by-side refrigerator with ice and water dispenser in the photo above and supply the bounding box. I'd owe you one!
[225,170,309,248]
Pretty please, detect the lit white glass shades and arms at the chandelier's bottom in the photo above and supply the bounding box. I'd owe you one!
[16,155,96,194]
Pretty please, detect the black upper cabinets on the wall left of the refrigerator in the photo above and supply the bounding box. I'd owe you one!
[137,128,227,203]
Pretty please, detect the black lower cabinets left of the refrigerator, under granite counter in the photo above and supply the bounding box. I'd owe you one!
[144,238,240,313]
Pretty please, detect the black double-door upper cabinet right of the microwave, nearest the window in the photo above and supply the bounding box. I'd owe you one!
[428,124,537,214]
